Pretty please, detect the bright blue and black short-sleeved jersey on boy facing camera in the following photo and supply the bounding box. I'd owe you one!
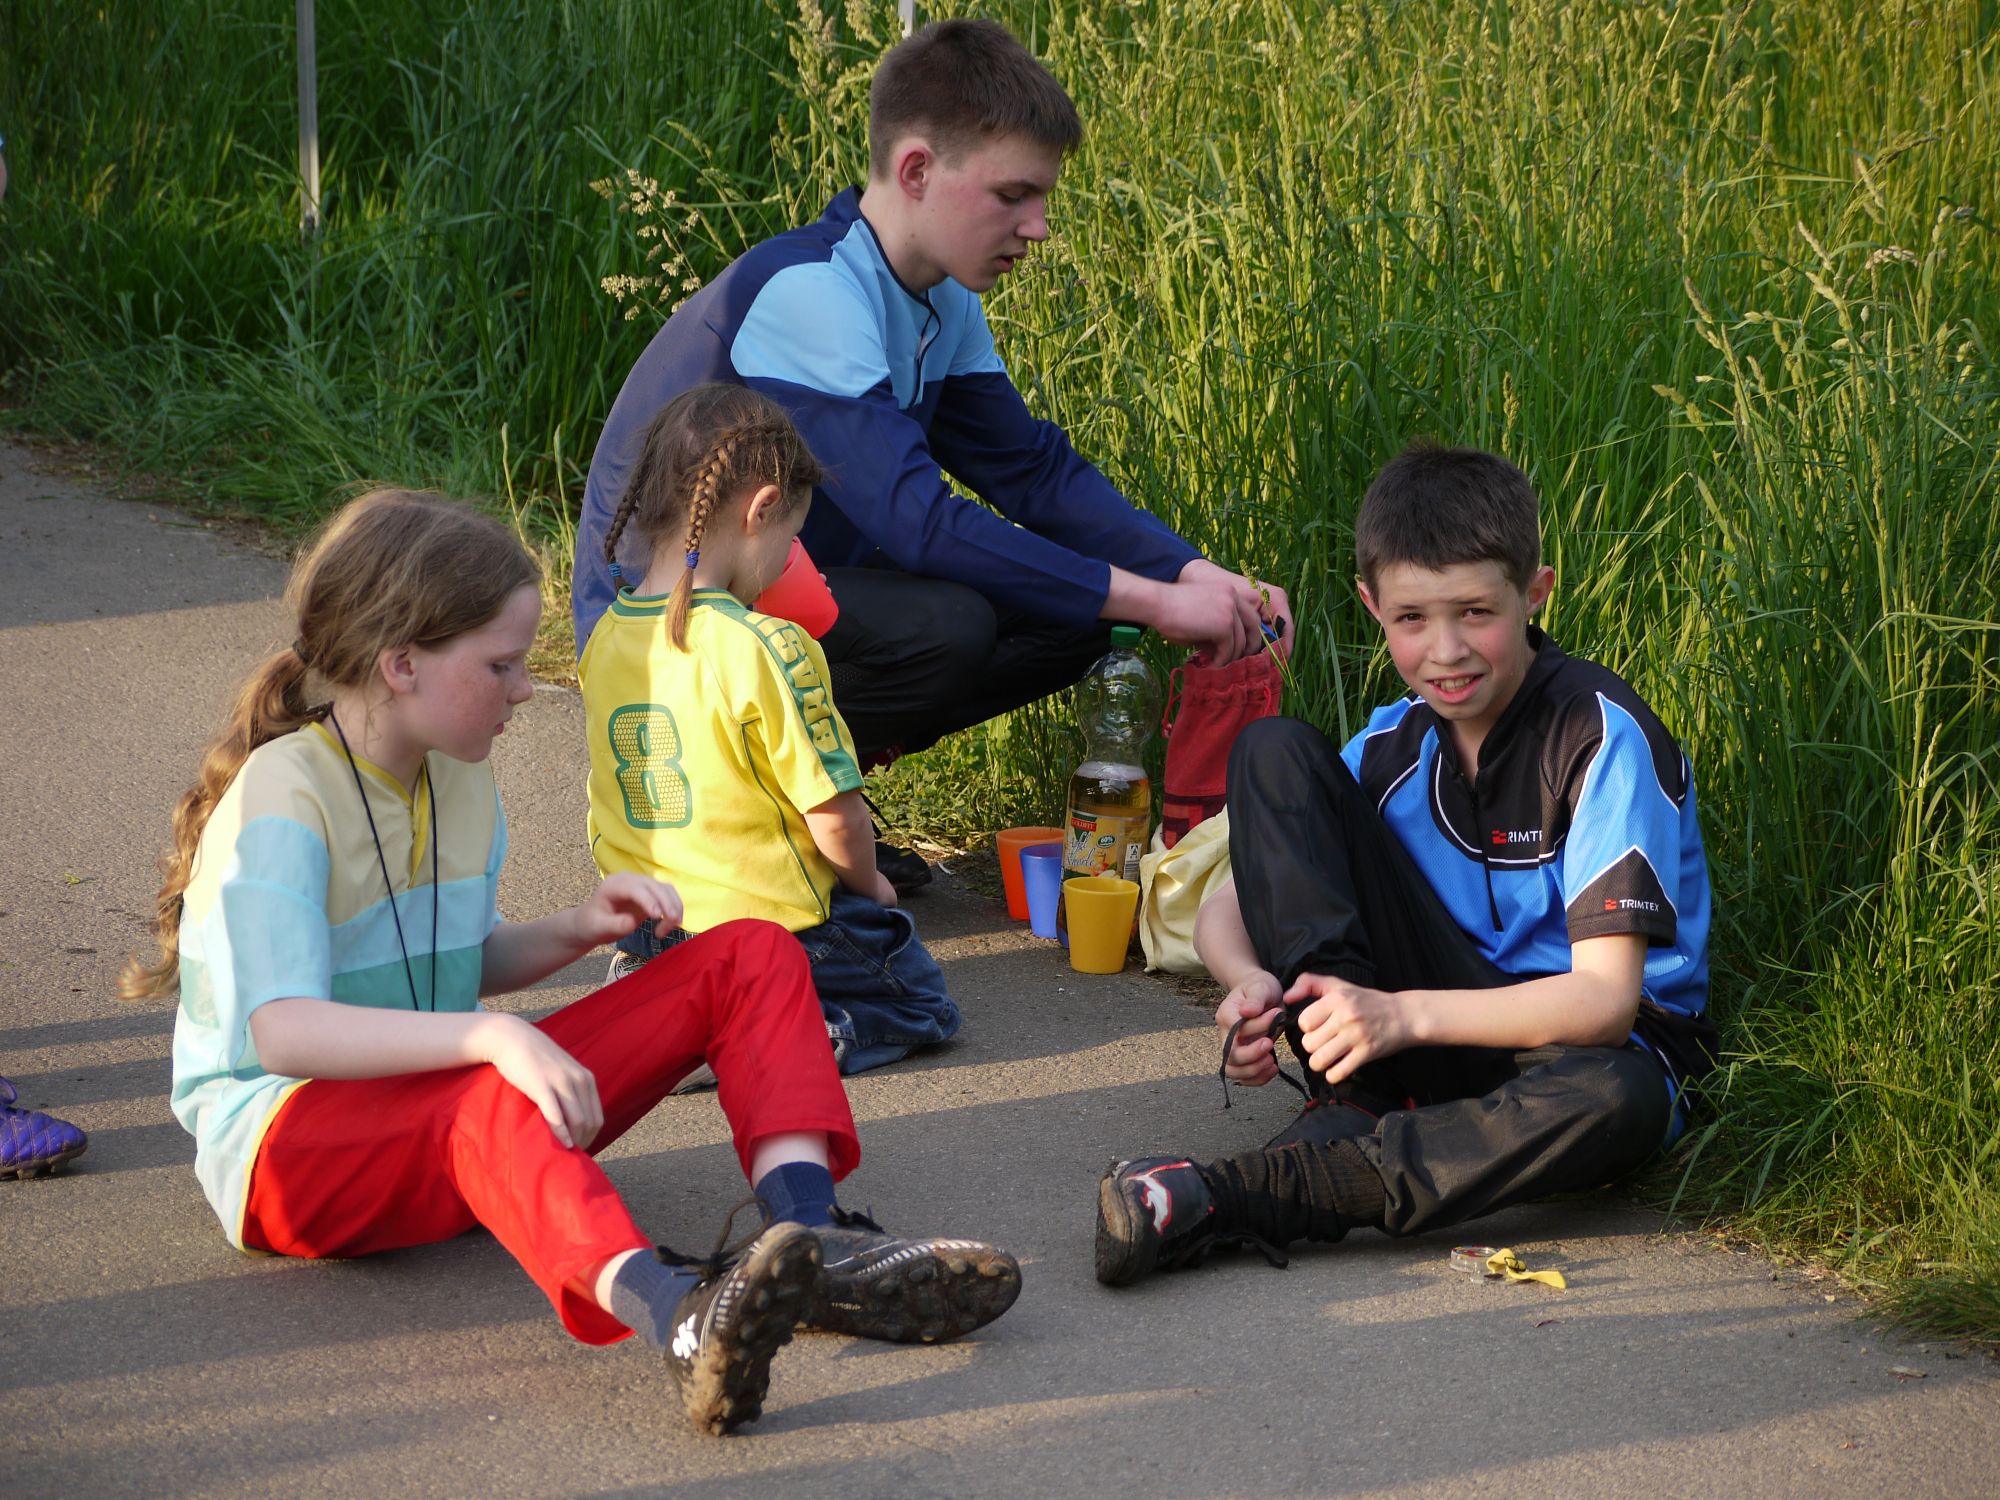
[1340,626,1716,1082]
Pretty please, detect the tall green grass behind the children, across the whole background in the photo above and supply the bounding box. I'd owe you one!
[0,0,2000,1334]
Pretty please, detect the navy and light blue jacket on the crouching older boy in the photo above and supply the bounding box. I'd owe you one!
[572,188,1200,650]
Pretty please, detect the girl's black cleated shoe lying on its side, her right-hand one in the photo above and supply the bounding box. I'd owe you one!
[806,1208,1020,1344]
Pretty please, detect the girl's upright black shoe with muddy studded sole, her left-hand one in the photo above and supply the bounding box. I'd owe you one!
[662,1224,820,1434]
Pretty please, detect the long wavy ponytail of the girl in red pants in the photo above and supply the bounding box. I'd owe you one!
[118,646,326,1000]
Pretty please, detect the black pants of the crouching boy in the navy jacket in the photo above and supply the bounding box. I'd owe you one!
[820,568,1110,760]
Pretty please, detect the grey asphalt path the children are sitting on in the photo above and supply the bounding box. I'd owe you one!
[0,446,2000,1500]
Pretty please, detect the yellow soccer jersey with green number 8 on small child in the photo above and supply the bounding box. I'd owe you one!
[576,588,862,932]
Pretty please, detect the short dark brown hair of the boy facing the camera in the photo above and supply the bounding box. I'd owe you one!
[1354,440,1542,590]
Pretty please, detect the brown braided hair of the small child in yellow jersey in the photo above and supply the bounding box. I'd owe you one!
[604,382,826,650]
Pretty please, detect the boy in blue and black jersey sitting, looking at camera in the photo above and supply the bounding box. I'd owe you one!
[1096,446,1714,1286]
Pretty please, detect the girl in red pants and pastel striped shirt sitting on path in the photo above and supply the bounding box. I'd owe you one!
[124,490,1020,1432]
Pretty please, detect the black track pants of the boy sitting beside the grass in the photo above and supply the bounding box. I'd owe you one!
[1228,718,1672,1234]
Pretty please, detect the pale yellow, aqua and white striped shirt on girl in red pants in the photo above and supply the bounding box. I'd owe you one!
[172,724,506,1248]
